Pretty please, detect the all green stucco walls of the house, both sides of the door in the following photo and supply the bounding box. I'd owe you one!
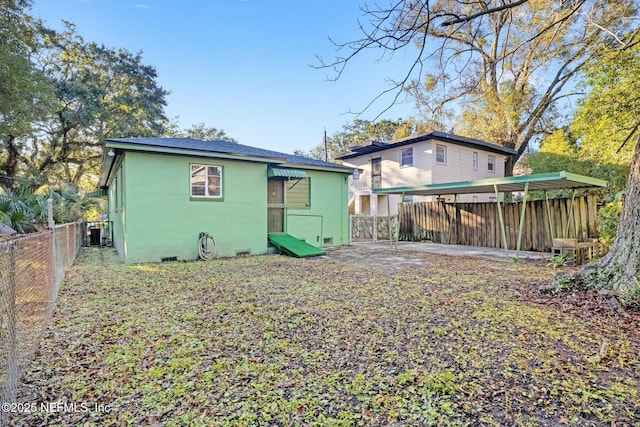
[109,152,349,263]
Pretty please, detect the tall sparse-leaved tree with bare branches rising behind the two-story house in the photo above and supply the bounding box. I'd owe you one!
[322,0,637,173]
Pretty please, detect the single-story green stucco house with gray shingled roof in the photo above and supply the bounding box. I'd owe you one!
[99,138,352,263]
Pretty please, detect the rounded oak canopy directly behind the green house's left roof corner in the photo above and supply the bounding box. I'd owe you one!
[24,23,167,186]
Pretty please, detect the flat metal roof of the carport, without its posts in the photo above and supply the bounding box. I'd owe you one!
[373,171,607,196]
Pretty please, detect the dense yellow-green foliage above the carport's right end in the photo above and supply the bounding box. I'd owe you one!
[526,45,640,196]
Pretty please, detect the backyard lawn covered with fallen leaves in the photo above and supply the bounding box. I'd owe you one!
[11,248,640,426]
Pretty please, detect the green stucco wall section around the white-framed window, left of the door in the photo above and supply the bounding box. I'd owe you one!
[110,152,267,262]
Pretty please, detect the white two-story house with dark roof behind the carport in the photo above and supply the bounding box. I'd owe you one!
[336,132,516,215]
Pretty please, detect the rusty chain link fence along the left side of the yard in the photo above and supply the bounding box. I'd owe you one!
[0,222,84,425]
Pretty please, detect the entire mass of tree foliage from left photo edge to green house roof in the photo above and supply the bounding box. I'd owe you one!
[0,11,168,191]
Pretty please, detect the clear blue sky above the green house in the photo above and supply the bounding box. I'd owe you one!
[30,0,416,153]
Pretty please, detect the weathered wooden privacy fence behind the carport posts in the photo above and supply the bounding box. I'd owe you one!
[398,196,598,252]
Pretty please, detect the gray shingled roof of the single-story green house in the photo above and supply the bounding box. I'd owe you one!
[106,138,352,171]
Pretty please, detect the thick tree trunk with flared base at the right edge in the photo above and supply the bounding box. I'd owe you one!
[555,138,640,308]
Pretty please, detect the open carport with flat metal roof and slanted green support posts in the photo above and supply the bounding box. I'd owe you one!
[373,171,607,258]
